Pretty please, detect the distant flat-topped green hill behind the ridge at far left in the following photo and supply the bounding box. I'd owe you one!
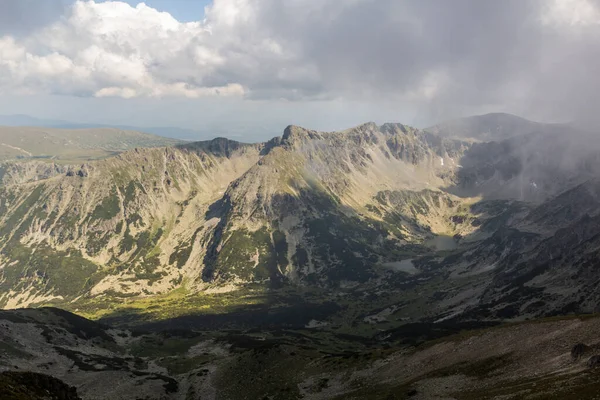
[0,126,181,162]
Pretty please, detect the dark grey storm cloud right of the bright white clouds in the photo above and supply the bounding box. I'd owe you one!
[234,0,572,119]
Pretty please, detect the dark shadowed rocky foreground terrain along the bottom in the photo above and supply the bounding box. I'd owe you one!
[0,309,600,400]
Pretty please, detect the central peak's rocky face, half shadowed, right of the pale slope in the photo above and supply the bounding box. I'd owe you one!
[203,124,474,284]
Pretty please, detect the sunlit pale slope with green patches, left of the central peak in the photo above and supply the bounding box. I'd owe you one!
[0,140,260,307]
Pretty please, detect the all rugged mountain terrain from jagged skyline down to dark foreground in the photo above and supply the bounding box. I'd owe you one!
[0,114,600,400]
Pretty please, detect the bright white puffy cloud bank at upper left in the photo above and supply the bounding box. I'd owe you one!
[0,1,244,98]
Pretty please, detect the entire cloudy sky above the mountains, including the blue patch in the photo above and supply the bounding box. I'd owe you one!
[0,0,600,141]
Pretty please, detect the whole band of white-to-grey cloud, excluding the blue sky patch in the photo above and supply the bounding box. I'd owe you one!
[0,0,600,123]
